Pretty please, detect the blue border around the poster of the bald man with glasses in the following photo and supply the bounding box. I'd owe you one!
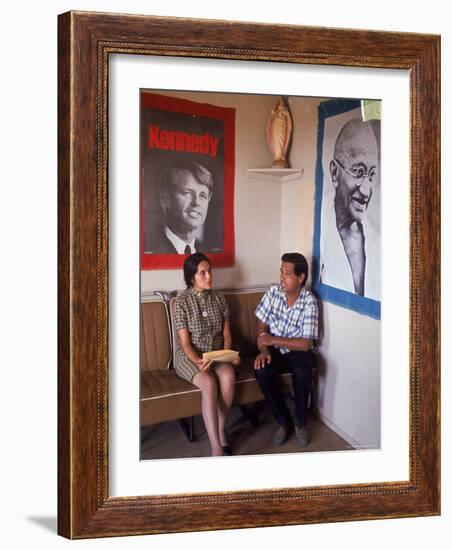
[312,99,381,319]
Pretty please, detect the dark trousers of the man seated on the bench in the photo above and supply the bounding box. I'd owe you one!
[254,346,313,429]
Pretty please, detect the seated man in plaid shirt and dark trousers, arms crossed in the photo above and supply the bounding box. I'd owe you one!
[254,252,318,447]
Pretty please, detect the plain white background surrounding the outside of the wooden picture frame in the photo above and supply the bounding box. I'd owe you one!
[0,0,452,550]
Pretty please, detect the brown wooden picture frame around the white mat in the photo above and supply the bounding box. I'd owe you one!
[58,12,440,538]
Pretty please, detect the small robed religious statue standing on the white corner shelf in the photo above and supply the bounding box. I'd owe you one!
[267,98,292,168]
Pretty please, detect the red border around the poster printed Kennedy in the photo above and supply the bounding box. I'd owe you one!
[140,94,235,270]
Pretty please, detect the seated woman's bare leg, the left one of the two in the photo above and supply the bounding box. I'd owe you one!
[192,371,223,456]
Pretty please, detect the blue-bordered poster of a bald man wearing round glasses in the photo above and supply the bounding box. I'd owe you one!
[313,99,381,319]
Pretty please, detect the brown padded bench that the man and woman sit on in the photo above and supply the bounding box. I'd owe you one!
[140,291,292,438]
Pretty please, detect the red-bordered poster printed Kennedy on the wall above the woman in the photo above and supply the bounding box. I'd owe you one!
[140,91,235,270]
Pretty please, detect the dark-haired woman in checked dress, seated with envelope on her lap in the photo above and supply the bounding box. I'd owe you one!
[174,252,240,456]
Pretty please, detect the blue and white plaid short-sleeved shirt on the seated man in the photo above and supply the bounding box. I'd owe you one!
[254,285,319,353]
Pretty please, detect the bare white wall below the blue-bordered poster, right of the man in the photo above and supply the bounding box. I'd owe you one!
[316,302,381,449]
